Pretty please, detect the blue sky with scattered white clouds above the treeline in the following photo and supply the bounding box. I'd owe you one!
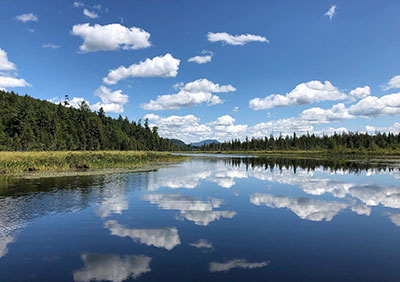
[0,0,400,142]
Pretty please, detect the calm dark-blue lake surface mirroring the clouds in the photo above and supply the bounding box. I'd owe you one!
[0,157,400,282]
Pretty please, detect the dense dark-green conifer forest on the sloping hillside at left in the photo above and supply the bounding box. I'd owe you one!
[0,91,175,151]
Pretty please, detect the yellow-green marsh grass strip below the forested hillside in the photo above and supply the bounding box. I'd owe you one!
[0,151,185,176]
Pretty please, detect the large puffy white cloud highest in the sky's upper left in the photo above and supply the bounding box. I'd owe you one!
[72,23,151,53]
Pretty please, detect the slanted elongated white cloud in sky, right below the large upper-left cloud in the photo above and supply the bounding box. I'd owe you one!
[103,54,180,84]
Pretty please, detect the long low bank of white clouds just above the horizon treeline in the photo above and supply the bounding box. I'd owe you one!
[146,85,400,143]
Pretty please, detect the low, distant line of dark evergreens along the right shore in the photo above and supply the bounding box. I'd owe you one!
[202,132,400,151]
